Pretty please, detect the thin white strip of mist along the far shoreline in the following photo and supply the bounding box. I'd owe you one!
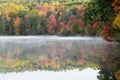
[0,36,103,41]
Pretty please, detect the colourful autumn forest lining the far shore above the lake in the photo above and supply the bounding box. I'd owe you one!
[0,0,120,41]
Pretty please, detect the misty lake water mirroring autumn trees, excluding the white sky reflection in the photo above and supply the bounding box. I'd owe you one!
[0,36,120,80]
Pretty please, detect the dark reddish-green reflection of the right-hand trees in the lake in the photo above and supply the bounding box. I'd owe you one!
[90,43,120,80]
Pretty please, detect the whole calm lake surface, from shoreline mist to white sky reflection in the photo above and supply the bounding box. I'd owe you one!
[0,36,120,80]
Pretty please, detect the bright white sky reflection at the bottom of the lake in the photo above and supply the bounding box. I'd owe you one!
[0,68,98,80]
